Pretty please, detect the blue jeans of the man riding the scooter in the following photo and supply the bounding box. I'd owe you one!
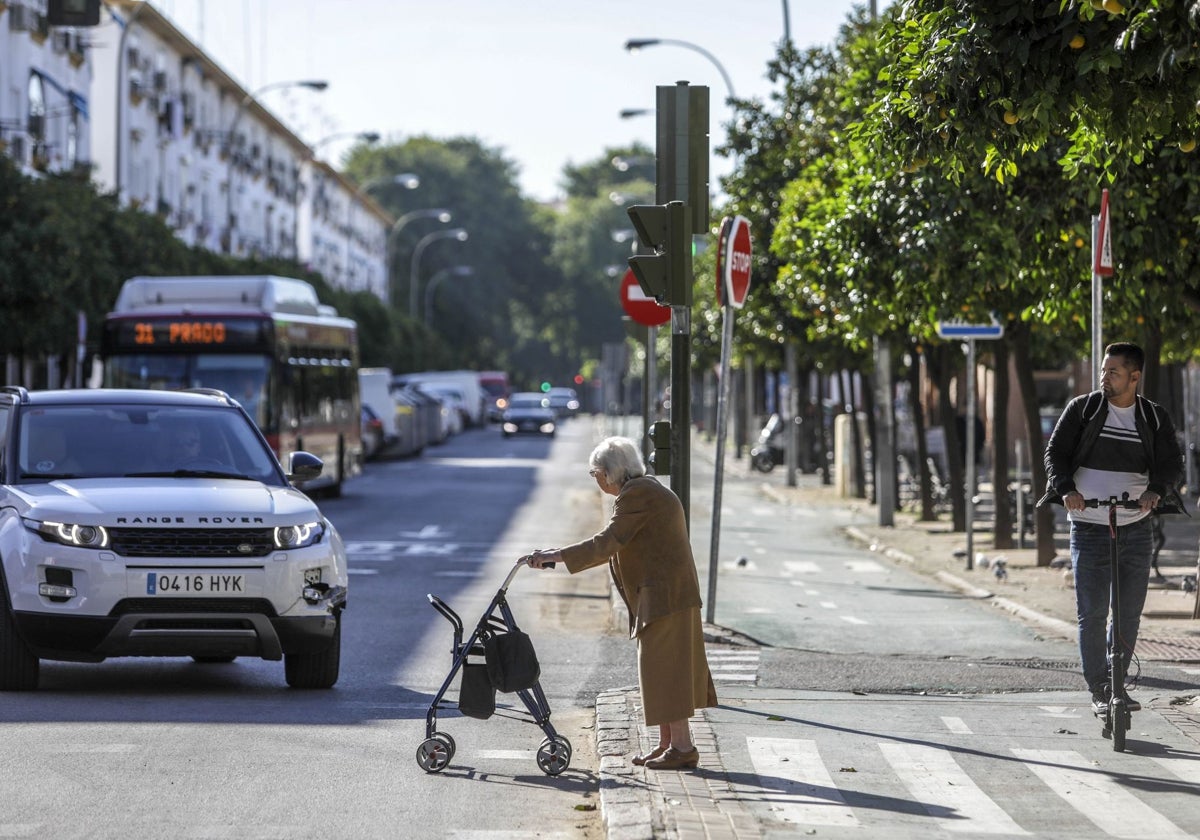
[1070,516,1153,691]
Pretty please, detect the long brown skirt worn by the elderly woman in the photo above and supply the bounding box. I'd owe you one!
[637,607,716,726]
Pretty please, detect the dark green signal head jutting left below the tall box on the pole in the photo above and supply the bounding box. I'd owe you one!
[628,202,691,306]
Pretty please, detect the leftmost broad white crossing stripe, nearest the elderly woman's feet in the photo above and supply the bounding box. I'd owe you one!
[745,738,859,826]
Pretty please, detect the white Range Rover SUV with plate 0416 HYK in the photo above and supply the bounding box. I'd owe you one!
[0,386,347,691]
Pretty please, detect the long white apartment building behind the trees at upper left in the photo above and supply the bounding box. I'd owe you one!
[0,0,392,299]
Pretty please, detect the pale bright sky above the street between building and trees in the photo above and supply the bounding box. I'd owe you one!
[152,0,864,202]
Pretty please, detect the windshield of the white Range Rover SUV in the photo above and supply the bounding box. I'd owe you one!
[17,403,286,485]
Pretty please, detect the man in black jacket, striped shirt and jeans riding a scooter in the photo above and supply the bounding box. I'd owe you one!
[1038,342,1183,715]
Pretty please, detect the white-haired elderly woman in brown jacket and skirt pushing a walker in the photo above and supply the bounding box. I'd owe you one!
[523,438,716,770]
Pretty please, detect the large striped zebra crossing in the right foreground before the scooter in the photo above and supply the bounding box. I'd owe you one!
[738,718,1200,840]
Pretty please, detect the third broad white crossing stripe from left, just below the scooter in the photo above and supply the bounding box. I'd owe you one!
[1013,749,1192,840]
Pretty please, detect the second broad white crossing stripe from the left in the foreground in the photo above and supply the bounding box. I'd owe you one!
[880,744,1028,835]
